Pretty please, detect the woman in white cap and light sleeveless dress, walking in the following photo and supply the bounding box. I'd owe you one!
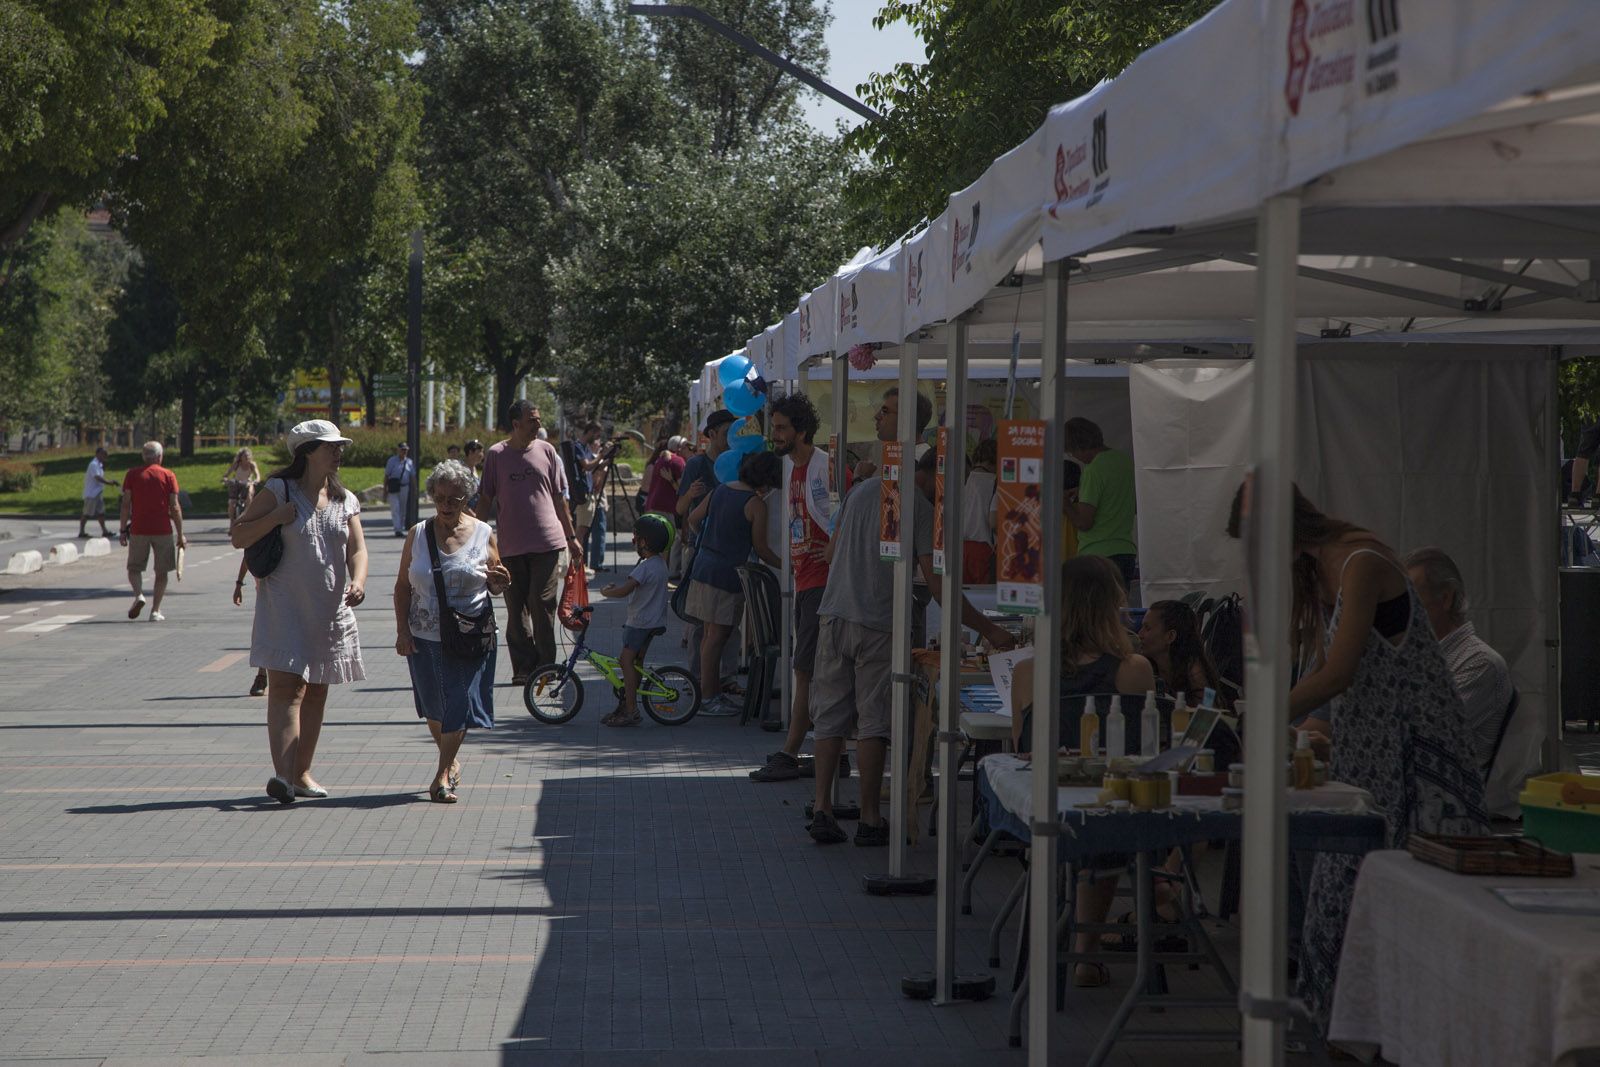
[232,419,366,805]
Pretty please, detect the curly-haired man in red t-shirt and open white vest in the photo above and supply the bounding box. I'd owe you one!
[750,394,835,782]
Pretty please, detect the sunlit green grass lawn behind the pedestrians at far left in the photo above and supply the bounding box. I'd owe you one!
[0,446,384,525]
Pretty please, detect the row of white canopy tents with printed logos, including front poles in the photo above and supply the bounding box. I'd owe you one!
[694,0,1600,1064]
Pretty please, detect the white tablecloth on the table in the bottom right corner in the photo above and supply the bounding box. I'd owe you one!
[1328,851,1600,1067]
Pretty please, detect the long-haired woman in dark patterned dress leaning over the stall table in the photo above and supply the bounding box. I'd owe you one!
[1227,483,1488,1030]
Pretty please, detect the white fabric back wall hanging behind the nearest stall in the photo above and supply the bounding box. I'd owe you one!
[1130,344,1555,814]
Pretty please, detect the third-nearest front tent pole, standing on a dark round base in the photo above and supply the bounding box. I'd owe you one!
[934,318,966,1005]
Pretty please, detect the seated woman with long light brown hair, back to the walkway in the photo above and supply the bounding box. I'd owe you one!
[1011,555,1155,987]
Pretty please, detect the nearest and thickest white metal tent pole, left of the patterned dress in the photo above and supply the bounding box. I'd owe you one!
[1238,194,1299,1067]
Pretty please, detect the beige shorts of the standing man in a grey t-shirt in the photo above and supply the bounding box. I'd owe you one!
[811,614,894,741]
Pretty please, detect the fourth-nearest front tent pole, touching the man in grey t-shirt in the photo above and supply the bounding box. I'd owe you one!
[883,346,922,878]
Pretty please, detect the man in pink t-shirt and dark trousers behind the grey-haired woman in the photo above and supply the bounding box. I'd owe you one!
[478,400,584,685]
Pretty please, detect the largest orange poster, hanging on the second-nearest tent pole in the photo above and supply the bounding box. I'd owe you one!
[995,419,1045,614]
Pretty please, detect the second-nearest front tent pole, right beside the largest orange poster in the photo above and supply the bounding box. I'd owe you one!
[1021,259,1069,1067]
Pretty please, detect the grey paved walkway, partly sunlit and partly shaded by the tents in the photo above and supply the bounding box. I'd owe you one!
[0,514,1237,1067]
